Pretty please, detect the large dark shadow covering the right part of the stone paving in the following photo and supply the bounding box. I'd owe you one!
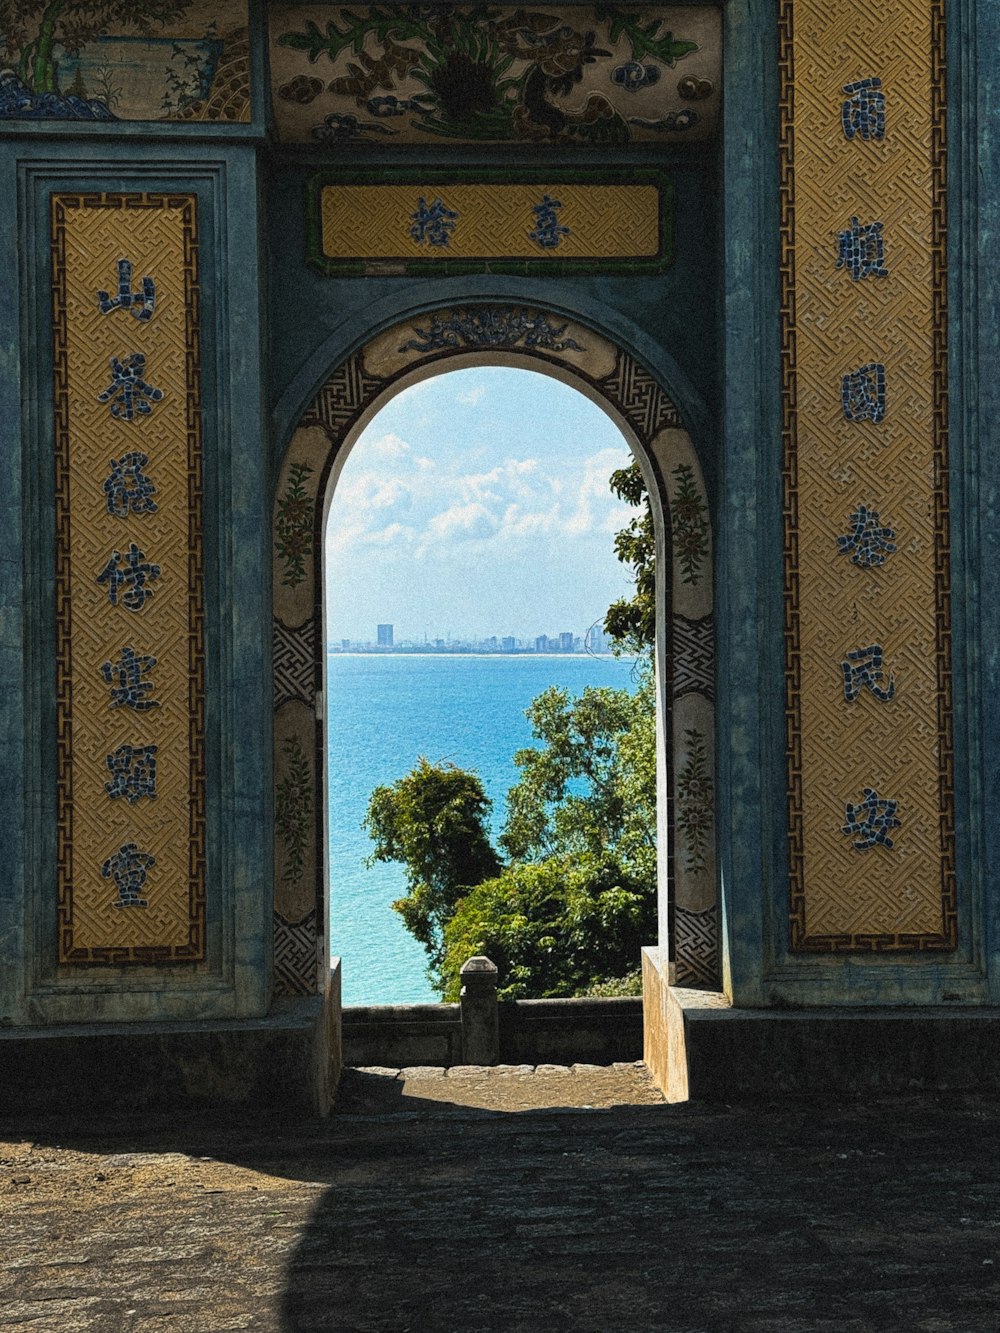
[283,1100,1000,1333]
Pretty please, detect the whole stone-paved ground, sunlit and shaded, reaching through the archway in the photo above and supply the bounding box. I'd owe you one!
[0,1065,1000,1333]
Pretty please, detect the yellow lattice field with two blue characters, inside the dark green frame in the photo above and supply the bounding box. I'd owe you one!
[321,181,660,260]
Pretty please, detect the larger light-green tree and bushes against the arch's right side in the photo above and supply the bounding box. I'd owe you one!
[439,677,656,1000]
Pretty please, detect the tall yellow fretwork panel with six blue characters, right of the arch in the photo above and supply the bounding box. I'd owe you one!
[780,0,956,952]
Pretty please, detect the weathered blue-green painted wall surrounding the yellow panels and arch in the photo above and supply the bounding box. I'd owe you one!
[0,0,1000,1022]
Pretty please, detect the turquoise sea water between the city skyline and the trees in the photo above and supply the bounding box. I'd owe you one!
[328,653,642,1004]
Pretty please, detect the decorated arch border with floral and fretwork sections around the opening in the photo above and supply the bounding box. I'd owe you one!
[272,309,719,994]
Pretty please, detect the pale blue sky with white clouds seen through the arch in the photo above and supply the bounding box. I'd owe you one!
[325,367,645,643]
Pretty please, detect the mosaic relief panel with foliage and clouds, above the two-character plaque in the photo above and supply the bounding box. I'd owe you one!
[268,4,721,149]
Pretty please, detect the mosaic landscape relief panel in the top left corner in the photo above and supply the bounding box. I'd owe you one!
[0,0,251,128]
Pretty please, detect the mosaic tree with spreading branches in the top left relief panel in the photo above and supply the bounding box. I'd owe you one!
[0,0,191,92]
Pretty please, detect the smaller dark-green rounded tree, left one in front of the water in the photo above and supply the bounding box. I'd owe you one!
[364,756,500,969]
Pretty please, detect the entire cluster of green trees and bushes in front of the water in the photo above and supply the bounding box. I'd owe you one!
[365,669,656,998]
